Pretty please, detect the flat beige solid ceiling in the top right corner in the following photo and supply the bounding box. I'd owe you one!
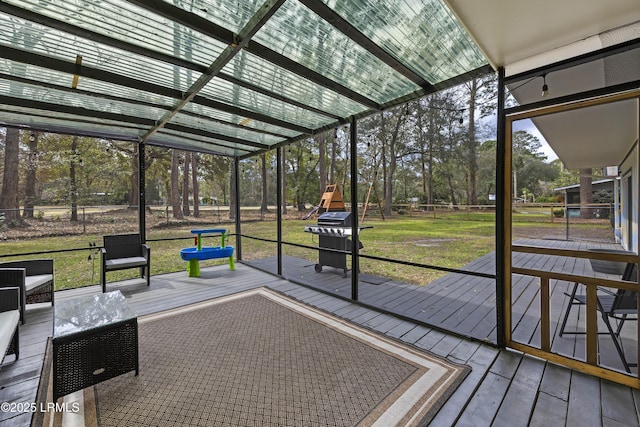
[445,0,640,75]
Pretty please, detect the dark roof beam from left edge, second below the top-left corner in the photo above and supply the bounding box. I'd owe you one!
[0,45,313,133]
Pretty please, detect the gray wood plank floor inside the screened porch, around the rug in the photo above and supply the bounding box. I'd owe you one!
[0,258,640,427]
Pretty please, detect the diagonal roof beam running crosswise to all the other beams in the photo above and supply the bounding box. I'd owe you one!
[140,0,285,142]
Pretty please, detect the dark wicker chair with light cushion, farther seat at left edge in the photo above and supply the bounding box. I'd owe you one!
[0,259,55,324]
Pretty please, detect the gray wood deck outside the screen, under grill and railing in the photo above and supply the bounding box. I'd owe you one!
[247,239,637,372]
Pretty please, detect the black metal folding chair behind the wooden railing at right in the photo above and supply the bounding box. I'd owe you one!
[559,261,638,373]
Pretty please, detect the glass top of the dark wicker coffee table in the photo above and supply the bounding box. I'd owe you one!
[53,291,137,338]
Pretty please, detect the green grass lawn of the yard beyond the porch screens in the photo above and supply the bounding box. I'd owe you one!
[0,212,576,289]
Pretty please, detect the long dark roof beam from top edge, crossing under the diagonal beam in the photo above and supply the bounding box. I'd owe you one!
[128,0,380,110]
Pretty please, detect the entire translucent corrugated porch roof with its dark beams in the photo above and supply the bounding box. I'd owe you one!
[0,0,486,156]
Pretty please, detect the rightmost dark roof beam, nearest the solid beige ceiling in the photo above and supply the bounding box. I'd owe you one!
[298,0,433,92]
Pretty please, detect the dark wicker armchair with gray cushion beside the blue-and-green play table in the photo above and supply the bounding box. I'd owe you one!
[100,234,151,292]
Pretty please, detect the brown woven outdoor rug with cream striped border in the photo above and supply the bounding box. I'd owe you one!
[37,288,470,427]
